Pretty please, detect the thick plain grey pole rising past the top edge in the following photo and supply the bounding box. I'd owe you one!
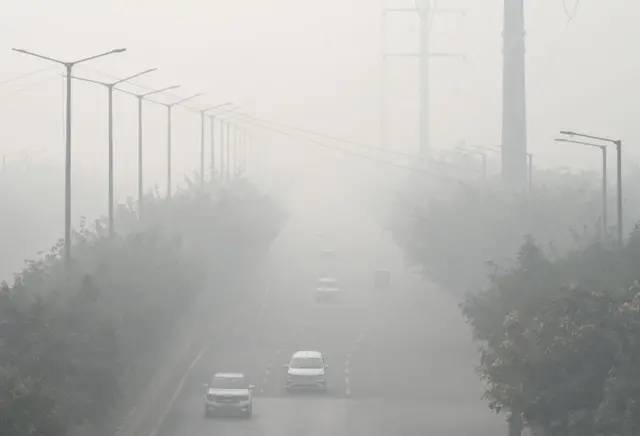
[502,0,528,192]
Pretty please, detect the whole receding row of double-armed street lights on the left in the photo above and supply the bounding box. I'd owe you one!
[13,48,246,268]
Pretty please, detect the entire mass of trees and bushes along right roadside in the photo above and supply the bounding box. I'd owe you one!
[391,168,640,436]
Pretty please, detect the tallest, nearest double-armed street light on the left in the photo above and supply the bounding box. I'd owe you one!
[12,48,127,271]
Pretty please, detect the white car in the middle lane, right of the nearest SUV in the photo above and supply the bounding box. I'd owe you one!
[284,351,329,392]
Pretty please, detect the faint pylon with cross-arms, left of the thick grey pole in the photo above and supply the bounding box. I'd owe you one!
[380,0,465,157]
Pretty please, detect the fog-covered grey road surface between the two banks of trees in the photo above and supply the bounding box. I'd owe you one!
[155,210,506,436]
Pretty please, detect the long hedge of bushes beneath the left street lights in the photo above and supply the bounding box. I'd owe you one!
[0,180,283,436]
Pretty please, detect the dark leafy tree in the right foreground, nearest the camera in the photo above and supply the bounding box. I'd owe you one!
[462,231,640,436]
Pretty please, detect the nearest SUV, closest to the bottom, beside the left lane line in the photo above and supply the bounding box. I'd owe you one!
[204,373,253,418]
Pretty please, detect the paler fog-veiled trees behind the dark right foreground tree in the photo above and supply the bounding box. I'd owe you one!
[387,169,624,294]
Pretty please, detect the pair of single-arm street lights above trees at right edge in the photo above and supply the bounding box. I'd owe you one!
[556,130,624,246]
